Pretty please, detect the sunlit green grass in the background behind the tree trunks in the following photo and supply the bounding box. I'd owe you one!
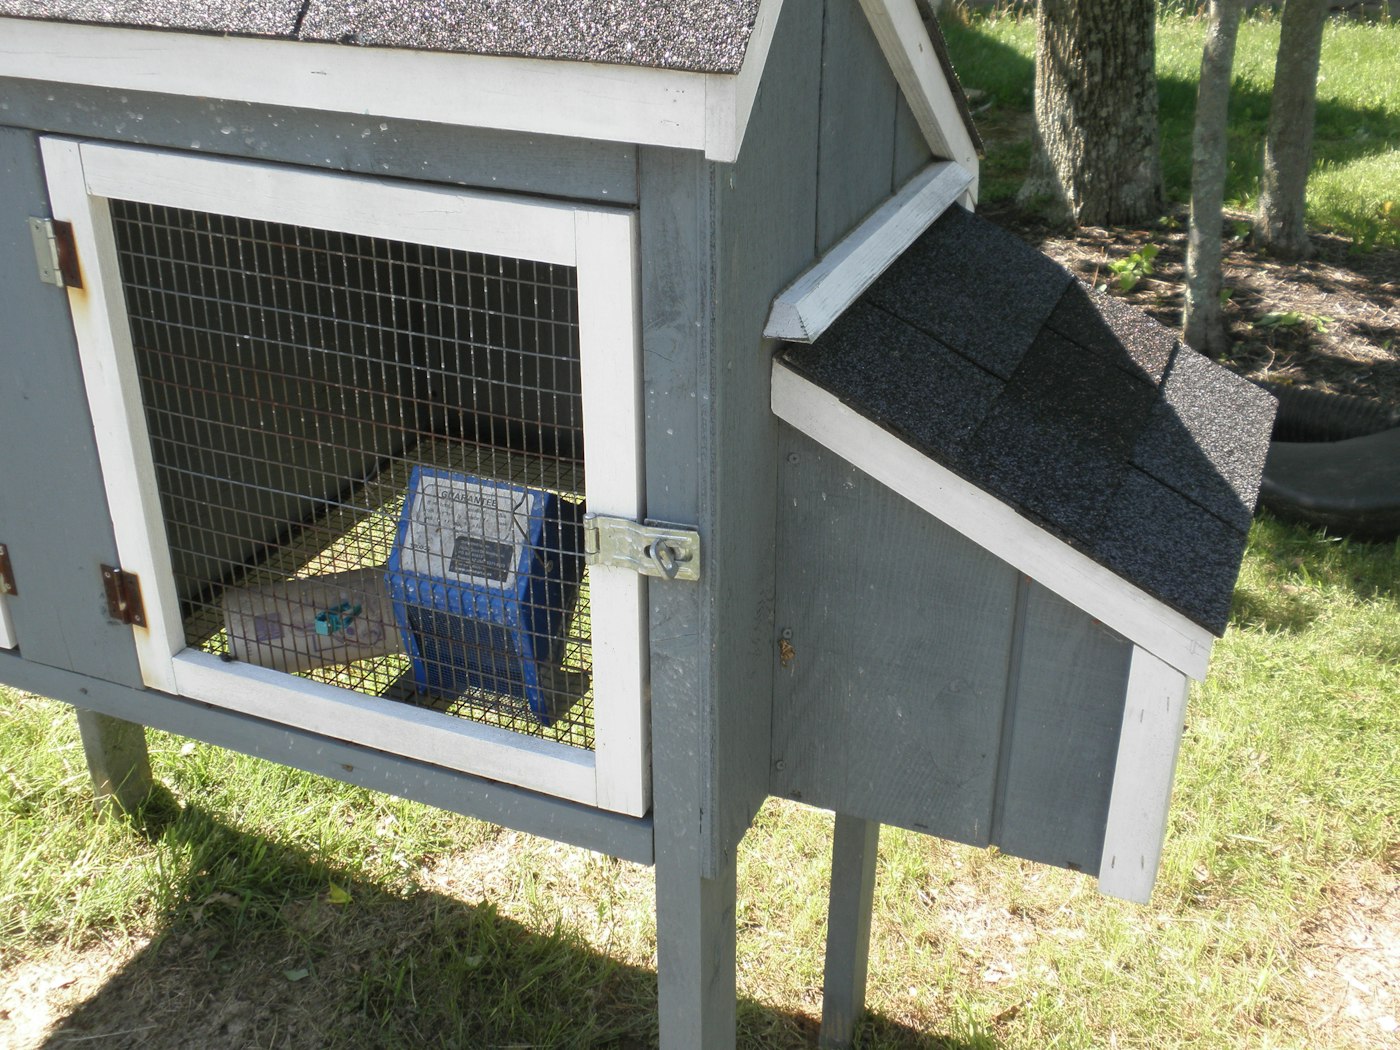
[946,13,1400,249]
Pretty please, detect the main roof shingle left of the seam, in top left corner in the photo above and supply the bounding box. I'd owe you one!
[0,0,301,36]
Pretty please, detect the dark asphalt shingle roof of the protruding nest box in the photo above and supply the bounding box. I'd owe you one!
[783,207,1275,634]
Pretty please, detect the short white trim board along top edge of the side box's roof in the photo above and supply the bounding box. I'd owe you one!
[763,161,972,343]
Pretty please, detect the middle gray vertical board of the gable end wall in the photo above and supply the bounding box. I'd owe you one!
[816,0,899,255]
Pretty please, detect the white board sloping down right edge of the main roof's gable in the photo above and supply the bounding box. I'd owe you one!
[860,0,977,197]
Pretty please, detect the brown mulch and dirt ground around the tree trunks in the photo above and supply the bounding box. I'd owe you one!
[980,206,1400,405]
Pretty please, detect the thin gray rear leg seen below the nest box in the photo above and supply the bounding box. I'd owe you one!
[820,813,879,1050]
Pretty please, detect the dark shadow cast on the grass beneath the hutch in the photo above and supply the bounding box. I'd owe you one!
[35,812,998,1050]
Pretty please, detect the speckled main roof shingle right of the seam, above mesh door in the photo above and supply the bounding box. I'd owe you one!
[301,0,757,73]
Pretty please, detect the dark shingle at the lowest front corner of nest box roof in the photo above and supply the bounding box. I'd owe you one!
[1091,470,1246,634]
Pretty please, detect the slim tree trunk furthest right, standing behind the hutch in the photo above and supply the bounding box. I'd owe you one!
[1254,0,1329,259]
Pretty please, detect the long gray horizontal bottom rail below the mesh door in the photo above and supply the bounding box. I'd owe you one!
[0,652,652,864]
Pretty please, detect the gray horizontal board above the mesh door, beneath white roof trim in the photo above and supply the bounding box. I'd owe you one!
[0,78,637,204]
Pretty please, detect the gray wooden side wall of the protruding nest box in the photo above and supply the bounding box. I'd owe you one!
[771,427,1133,874]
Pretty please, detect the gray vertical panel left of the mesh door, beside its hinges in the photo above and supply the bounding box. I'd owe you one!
[0,127,141,685]
